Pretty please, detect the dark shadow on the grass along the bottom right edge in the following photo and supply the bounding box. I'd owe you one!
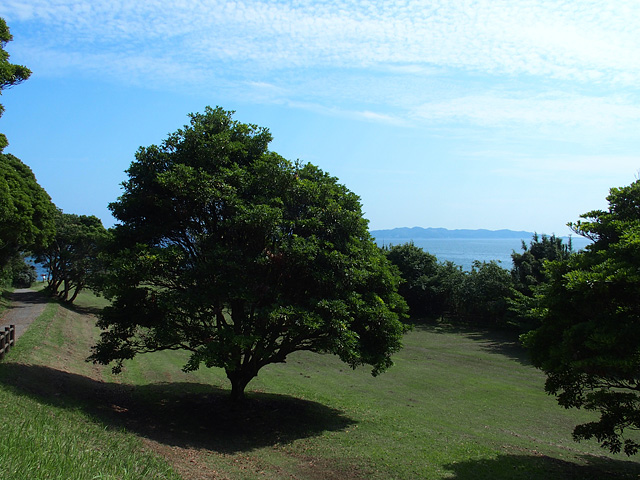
[444,455,640,480]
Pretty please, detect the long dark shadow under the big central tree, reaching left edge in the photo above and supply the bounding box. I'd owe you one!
[0,363,355,453]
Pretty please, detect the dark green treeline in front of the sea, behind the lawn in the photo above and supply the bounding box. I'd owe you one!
[383,234,572,331]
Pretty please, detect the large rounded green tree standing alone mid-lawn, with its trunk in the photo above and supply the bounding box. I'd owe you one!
[90,108,406,400]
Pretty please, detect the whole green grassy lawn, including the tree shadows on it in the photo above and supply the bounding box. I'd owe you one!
[0,295,640,480]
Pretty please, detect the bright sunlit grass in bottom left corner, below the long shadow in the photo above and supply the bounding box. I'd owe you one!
[0,388,178,480]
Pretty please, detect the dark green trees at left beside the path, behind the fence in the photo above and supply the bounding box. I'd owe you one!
[0,153,109,296]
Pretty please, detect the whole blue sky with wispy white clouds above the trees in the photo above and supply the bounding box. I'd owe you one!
[0,0,640,235]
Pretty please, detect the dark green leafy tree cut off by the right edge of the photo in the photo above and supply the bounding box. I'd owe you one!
[524,181,640,455]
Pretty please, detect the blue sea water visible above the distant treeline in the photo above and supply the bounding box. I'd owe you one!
[375,237,591,270]
